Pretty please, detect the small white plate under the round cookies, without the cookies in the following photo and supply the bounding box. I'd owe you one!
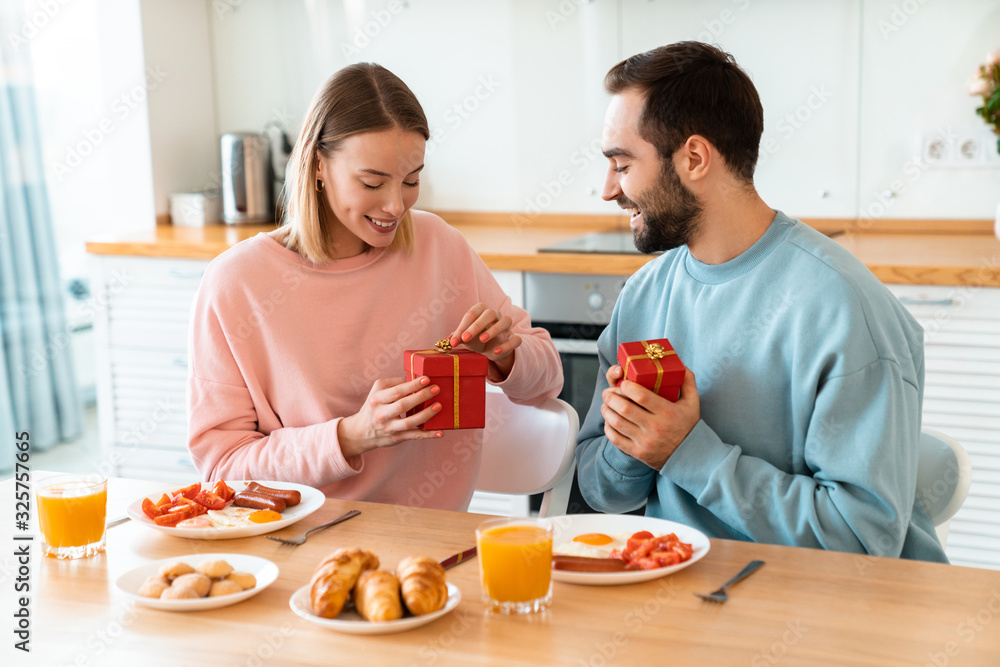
[115,554,278,611]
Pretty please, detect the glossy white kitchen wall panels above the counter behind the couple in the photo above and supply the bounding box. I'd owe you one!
[199,0,1000,218]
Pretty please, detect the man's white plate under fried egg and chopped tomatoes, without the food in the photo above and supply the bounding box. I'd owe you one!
[549,514,709,586]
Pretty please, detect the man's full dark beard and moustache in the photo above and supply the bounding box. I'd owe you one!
[616,160,702,254]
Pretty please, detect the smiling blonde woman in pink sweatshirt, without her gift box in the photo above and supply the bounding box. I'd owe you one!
[189,63,562,510]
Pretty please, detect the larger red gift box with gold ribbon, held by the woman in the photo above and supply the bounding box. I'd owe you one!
[403,340,489,431]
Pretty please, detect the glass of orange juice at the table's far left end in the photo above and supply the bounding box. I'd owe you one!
[35,473,108,558]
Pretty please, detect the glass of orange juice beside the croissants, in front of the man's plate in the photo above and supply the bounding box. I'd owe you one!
[476,518,552,614]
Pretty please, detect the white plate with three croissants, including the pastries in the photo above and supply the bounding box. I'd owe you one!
[289,547,462,635]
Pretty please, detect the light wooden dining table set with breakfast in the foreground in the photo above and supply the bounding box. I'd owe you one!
[0,478,1000,667]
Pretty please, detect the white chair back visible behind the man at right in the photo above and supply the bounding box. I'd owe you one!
[917,428,972,546]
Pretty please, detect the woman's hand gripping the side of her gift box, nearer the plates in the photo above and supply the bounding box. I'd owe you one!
[337,376,442,458]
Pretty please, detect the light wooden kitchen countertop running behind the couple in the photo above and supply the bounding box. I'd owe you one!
[87,211,1000,287]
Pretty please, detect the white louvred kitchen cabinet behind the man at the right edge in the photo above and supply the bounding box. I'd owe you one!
[889,285,1000,569]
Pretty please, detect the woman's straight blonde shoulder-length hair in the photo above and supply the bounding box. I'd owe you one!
[279,63,430,264]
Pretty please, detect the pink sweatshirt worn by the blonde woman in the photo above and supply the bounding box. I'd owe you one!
[188,211,562,510]
